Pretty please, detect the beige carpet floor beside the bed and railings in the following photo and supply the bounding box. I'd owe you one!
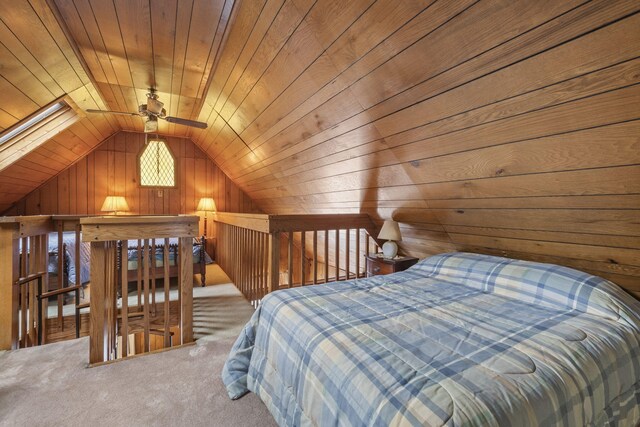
[0,266,276,426]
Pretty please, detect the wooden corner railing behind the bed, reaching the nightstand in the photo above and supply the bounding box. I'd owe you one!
[215,212,377,306]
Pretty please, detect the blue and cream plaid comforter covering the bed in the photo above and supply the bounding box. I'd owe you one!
[222,253,640,426]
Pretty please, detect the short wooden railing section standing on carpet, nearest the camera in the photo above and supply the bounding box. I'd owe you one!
[80,216,199,364]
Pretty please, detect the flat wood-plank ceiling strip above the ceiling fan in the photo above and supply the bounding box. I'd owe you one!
[54,0,234,136]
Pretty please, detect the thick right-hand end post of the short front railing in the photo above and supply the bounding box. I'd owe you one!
[178,237,193,344]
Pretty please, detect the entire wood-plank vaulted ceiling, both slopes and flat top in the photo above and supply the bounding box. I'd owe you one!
[0,0,640,291]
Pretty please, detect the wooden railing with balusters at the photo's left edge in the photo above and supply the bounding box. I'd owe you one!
[0,215,90,349]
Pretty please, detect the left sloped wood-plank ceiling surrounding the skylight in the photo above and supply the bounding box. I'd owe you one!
[0,0,117,212]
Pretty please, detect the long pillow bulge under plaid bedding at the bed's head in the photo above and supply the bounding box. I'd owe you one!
[412,252,640,330]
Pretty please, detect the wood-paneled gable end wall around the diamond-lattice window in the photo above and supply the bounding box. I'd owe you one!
[8,132,260,241]
